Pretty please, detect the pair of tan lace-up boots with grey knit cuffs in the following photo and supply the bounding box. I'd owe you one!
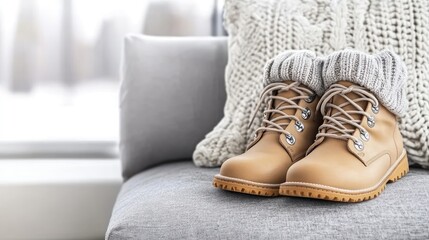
[213,50,408,202]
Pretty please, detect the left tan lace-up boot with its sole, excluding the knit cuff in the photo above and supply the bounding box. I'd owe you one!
[213,81,321,196]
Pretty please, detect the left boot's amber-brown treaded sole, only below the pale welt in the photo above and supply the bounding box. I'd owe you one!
[213,176,279,197]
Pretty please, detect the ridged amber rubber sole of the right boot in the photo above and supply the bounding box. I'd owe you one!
[279,151,409,202]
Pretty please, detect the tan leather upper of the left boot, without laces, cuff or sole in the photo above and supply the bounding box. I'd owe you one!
[220,81,321,184]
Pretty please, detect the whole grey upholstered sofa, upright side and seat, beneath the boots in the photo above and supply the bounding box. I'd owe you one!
[106,35,429,239]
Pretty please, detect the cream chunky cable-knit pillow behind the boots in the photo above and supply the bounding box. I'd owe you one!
[193,0,429,167]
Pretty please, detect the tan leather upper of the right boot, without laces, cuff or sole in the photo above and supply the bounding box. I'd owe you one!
[286,81,404,190]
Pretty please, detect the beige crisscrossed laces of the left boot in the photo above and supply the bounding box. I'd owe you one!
[249,82,315,144]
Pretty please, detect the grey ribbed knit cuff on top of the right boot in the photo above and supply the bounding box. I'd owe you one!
[322,50,408,116]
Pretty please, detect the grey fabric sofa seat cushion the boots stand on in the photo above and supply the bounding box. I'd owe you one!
[107,161,429,239]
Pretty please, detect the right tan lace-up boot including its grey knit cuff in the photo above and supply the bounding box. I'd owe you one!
[280,49,408,202]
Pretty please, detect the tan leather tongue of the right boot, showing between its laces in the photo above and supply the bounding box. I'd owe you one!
[328,81,368,133]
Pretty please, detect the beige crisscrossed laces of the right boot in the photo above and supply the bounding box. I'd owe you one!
[308,84,379,152]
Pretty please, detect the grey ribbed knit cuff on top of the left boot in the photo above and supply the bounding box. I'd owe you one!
[264,50,324,96]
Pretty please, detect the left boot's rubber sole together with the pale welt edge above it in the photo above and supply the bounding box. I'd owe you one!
[213,174,280,197]
